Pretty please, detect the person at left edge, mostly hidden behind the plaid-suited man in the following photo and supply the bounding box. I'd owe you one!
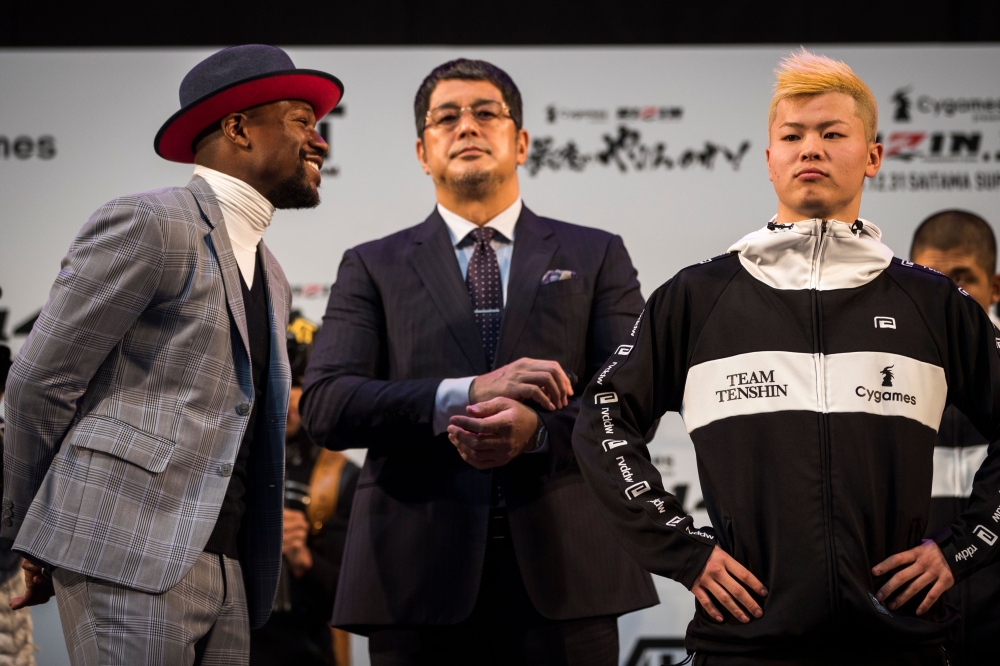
[0,291,35,666]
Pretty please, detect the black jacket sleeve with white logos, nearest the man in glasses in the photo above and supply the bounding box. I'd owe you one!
[573,256,739,588]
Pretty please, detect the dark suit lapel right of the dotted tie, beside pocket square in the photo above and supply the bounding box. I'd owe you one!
[494,207,559,368]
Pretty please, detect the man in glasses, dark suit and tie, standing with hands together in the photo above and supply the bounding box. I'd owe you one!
[302,59,657,666]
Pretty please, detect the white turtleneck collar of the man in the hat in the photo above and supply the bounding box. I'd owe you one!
[194,164,274,287]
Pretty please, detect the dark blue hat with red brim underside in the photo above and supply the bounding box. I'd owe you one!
[153,44,344,164]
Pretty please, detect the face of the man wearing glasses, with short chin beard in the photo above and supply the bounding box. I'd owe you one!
[417,79,528,202]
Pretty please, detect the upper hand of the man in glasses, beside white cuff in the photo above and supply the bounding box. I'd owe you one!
[469,358,573,410]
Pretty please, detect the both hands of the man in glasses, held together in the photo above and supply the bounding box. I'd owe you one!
[448,358,573,470]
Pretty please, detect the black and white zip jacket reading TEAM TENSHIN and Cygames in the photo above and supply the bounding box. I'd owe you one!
[573,220,1000,653]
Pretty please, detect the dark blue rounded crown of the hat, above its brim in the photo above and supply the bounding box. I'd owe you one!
[180,44,295,108]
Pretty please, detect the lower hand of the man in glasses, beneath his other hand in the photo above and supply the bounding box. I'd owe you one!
[448,398,539,469]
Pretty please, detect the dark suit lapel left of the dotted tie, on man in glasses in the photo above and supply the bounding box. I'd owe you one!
[410,208,490,375]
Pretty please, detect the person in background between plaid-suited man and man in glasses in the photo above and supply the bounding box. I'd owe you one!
[250,312,360,666]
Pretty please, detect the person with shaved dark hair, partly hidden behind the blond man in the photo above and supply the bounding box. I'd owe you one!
[910,210,1000,666]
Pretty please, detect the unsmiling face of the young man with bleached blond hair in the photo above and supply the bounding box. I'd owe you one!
[766,92,882,223]
